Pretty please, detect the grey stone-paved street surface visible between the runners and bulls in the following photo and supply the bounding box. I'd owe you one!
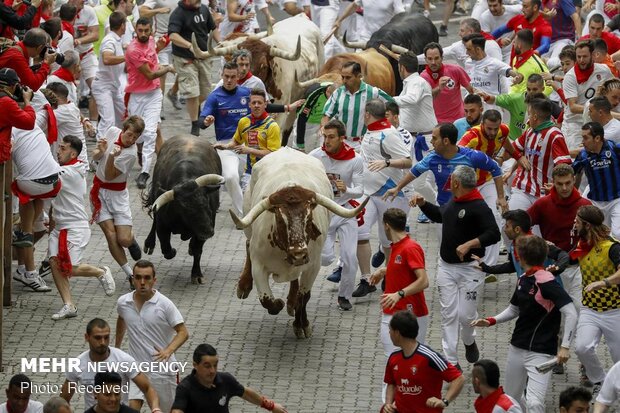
[0,5,611,413]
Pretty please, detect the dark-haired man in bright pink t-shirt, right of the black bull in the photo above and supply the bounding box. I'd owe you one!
[420,42,474,123]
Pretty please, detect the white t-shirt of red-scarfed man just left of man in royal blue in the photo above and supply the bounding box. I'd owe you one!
[360,126,411,195]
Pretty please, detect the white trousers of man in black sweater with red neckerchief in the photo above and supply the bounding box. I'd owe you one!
[437,258,484,365]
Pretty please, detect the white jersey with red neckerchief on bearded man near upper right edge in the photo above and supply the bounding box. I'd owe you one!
[562,63,613,124]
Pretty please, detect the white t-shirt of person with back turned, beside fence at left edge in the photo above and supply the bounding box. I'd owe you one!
[11,126,60,181]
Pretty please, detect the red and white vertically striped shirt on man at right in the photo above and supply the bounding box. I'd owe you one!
[512,125,571,196]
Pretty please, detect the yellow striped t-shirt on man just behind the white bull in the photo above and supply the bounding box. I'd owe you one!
[233,115,282,168]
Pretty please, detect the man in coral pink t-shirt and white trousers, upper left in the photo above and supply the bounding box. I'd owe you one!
[125,18,174,189]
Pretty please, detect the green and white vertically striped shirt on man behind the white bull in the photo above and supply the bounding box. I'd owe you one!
[323,81,394,138]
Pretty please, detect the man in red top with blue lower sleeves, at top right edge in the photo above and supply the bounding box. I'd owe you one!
[491,0,551,55]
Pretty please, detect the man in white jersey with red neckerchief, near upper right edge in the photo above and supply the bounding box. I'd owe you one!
[562,40,613,150]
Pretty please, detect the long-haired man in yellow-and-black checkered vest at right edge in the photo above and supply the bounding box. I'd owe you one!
[570,205,620,393]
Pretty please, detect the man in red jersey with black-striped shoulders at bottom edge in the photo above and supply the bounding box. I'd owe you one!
[381,311,465,413]
